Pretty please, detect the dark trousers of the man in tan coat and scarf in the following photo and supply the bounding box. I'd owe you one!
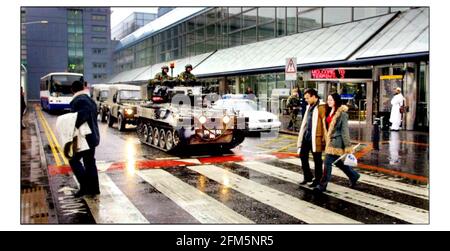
[300,141,323,184]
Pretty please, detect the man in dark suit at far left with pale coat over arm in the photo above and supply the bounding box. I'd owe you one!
[69,81,100,197]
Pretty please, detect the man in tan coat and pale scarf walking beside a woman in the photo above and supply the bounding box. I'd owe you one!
[297,89,326,187]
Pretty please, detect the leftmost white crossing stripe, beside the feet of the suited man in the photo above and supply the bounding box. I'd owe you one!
[85,173,149,224]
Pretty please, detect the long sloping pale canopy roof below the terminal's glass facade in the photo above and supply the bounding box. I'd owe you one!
[108,8,429,83]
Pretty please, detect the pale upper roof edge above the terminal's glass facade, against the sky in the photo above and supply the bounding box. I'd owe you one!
[115,7,206,51]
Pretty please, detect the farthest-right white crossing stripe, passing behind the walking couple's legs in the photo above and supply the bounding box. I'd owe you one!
[280,158,429,200]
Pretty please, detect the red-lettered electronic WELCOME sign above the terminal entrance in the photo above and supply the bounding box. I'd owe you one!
[311,68,372,80]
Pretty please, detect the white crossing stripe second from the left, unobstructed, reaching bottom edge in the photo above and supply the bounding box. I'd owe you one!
[137,169,254,224]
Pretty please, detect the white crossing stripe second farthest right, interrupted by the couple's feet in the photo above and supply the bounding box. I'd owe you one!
[237,161,428,224]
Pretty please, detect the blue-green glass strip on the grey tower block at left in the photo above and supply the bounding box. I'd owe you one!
[67,9,84,73]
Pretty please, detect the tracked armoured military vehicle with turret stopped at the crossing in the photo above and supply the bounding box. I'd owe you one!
[137,83,248,152]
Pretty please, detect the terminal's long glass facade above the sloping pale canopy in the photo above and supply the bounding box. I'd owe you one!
[113,7,407,73]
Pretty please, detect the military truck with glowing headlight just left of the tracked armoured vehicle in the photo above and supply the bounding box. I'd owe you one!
[105,84,143,131]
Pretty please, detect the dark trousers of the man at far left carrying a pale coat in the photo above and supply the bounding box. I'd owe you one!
[69,148,100,194]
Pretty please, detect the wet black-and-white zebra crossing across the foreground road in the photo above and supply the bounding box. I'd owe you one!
[71,158,429,224]
